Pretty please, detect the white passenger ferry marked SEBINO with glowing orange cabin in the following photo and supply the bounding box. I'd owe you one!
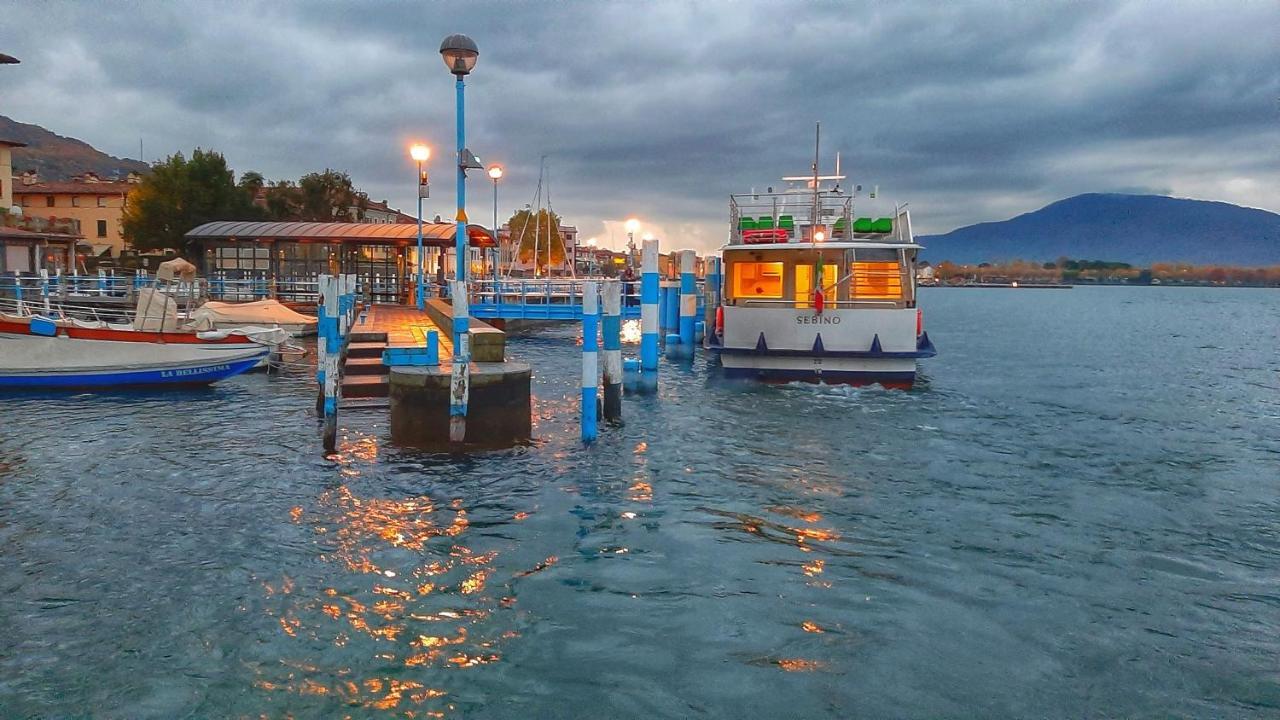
[707,169,937,388]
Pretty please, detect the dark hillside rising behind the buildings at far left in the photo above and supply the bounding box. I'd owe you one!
[0,115,151,181]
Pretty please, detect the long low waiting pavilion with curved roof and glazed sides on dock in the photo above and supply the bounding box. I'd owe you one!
[186,220,494,304]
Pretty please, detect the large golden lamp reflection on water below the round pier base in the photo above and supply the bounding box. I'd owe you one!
[253,439,542,717]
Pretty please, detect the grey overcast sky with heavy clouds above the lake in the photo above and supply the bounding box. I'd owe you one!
[0,0,1280,249]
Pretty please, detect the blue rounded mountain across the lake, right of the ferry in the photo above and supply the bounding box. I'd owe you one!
[916,193,1280,266]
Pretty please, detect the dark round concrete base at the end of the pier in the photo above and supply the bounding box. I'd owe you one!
[389,361,532,450]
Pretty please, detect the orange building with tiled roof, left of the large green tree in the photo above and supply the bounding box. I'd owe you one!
[11,168,142,258]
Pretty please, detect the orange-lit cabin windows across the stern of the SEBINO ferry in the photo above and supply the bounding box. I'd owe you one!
[724,247,915,307]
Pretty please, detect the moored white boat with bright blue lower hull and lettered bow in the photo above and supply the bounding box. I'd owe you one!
[0,327,271,389]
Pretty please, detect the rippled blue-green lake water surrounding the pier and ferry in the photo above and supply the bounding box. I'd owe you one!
[0,288,1280,719]
